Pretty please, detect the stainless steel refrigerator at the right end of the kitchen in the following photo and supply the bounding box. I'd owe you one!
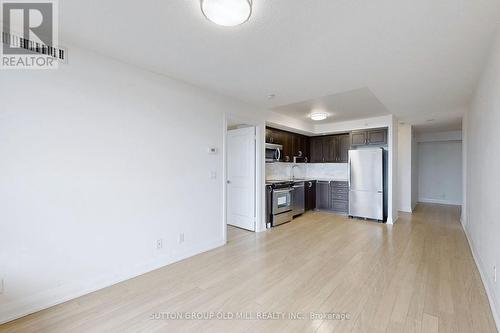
[349,148,386,221]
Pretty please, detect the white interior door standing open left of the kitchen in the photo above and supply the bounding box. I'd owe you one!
[227,127,255,231]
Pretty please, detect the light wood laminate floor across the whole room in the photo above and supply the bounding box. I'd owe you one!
[0,205,497,333]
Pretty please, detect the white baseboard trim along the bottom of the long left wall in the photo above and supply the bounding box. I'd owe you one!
[0,240,225,324]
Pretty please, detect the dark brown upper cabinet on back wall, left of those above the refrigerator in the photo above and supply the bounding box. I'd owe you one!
[309,134,350,163]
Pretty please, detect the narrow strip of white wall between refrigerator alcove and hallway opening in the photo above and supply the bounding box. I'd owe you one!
[398,124,413,213]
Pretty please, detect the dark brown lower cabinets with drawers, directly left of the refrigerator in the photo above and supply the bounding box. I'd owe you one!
[316,181,349,214]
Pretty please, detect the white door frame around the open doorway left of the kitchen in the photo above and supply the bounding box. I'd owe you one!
[221,113,266,243]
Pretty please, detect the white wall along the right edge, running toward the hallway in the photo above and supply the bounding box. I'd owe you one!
[464,27,500,327]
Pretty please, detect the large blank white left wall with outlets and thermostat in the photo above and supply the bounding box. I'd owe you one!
[0,47,264,322]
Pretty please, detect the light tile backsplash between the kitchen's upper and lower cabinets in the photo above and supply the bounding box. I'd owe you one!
[266,162,348,179]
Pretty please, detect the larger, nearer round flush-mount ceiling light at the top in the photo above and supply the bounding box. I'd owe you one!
[200,0,252,27]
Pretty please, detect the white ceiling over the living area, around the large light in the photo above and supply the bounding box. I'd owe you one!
[59,0,500,127]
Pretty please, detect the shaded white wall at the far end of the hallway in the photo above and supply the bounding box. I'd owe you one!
[418,141,462,205]
